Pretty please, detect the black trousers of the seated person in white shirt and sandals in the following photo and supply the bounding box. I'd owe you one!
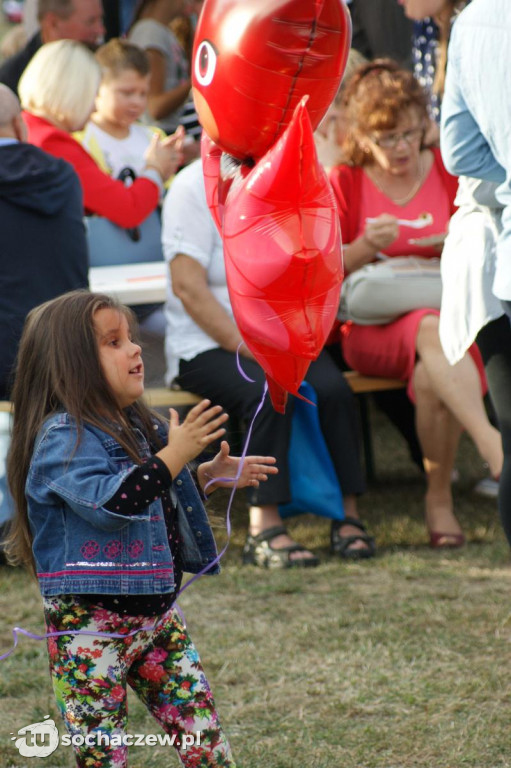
[177,349,365,506]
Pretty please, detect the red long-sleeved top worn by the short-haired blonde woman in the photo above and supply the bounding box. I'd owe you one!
[23,112,159,227]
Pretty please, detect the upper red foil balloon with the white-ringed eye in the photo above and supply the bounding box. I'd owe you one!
[192,0,351,160]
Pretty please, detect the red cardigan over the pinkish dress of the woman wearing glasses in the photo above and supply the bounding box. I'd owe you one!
[330,147,458,244]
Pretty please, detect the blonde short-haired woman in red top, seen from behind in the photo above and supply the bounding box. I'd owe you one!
[19,40,182,228]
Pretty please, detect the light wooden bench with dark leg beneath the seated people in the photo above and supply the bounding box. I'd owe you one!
[0,371,406,482]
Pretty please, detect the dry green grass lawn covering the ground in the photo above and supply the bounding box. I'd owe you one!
[0,404,511,768]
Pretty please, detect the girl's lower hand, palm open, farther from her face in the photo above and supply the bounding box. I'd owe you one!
[197,440,278,493]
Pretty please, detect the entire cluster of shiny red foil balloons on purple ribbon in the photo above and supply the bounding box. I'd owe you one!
[192,0,351,412]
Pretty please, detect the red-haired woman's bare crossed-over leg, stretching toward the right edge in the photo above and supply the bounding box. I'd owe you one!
[417,315,503,477]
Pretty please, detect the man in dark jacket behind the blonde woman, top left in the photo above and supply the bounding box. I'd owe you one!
[0,0,105,93]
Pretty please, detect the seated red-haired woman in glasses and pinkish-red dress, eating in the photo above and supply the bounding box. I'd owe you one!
[331,59,502,547]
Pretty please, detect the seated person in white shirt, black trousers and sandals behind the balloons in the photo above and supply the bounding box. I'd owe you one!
[163,161,374,567]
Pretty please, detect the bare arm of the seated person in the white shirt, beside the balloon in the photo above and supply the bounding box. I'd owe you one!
[170,253,253,359]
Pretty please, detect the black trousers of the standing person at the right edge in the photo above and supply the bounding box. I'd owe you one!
[476,315,511,544]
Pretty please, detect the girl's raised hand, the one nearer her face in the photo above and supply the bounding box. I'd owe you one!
[156,400,229,477]
